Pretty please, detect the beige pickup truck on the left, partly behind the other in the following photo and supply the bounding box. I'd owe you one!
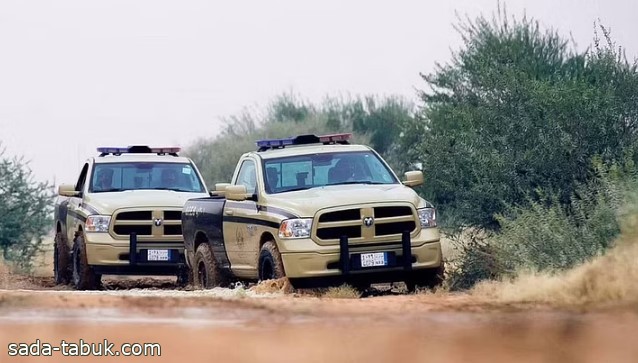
[54,146,209,289]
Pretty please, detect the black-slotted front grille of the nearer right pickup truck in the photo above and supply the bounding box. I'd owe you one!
[315,205,417,243]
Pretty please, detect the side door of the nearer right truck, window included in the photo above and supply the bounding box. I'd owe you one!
[223,159,259,278]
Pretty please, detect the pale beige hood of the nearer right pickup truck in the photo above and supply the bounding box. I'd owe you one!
[267,184,430,217]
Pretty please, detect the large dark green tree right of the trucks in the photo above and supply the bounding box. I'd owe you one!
[400,10,638,232]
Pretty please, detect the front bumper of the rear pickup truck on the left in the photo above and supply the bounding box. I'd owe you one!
[85,232,186,275]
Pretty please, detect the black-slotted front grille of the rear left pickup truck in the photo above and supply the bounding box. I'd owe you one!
[112,209,182,241]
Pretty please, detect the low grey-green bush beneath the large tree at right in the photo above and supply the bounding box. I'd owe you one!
[448,163,638,289]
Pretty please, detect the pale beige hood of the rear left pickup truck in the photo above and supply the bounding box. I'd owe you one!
[84,190,208,214]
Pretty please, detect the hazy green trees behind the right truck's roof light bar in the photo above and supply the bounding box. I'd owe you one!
[185,94,412,188]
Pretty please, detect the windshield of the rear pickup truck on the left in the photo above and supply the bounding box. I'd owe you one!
[89,162,204,193]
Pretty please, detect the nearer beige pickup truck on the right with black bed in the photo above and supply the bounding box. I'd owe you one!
[182,134,444,289]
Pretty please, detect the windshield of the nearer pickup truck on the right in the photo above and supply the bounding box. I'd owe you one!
[264,151,399,194]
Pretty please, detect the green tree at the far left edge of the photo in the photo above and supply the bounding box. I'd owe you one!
[0,150,54,269]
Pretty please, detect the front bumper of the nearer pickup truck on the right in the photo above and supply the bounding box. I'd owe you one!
[279,228,442,279]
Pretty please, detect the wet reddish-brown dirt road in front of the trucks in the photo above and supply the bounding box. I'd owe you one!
[0,279,638,363]
